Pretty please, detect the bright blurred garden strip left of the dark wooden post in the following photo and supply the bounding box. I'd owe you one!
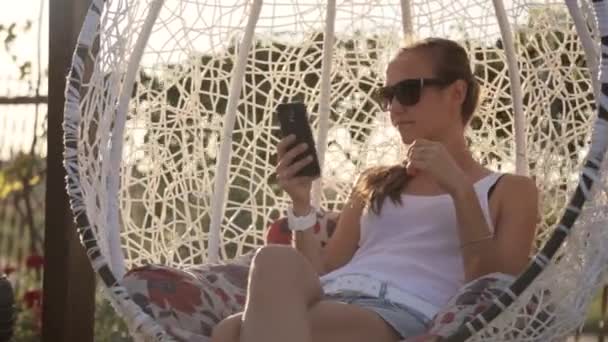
[0,0,49,341]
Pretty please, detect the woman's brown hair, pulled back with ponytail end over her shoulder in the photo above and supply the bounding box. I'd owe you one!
[353,38,479,215]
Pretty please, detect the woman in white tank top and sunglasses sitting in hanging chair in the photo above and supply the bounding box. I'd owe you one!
[212,38,537,342]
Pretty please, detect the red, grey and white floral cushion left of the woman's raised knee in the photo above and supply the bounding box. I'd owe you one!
[122,210,338,342]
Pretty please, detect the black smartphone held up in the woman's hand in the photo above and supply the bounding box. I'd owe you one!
[276,102,321,178]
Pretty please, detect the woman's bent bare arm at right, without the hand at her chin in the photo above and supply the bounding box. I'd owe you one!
[452,175,538,282]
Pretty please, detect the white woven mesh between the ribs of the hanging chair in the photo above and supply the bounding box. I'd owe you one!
[80,0,607,341]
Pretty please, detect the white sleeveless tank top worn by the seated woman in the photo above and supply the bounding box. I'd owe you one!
[321,173,501,307]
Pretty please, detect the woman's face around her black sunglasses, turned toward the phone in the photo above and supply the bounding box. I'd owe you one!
[386,51,462,144]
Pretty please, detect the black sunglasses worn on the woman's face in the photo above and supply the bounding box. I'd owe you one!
[376,78,454,111]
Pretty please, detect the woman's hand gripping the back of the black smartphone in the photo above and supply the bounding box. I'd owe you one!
[276,134,314,214]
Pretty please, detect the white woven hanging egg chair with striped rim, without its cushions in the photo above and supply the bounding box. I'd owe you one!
[64,0,608,341]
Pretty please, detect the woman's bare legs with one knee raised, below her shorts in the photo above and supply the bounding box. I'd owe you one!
[211,246,410,342]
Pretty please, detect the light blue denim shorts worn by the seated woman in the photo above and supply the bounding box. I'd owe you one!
[323,290,431,338]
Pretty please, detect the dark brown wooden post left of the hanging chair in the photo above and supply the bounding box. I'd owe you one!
[42,0,95,342]
